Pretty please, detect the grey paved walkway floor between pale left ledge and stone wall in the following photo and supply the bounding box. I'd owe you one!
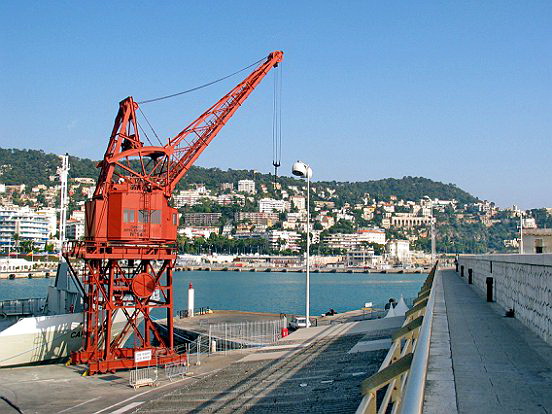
[441,270,552,414]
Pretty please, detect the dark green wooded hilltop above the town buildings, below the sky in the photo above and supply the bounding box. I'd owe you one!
[0,148,477,205]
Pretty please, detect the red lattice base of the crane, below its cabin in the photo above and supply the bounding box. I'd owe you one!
[64,242,182,375]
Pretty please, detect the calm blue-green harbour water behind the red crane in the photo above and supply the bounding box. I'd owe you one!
[0,272,427,315]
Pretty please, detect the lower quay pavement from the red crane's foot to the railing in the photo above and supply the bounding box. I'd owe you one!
[0,312,404,414]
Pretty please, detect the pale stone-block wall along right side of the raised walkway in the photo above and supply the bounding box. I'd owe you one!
[458,254,552,345]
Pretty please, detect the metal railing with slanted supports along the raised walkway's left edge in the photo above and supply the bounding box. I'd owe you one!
[356,263,437,414]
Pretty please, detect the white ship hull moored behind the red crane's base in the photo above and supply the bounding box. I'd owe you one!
[0,312,126,368]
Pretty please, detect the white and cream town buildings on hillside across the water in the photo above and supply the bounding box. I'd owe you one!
[0,164,552,266]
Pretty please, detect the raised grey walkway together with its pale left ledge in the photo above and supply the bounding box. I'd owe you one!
[424,261,552,414]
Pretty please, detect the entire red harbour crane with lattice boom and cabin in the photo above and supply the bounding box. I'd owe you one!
[64,51,283,374]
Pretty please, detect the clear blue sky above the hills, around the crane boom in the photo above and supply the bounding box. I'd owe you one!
[0,1,552,208]
